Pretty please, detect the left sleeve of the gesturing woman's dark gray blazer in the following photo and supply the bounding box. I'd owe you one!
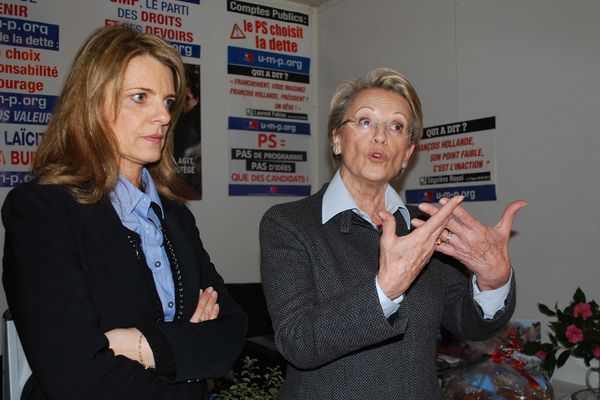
[260,207,407,369]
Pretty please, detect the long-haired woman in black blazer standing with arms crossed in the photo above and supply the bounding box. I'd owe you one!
[2,25,246,400]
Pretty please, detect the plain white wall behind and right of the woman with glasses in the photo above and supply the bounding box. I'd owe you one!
[318,0,600,383]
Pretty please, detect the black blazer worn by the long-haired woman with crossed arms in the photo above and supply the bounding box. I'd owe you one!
[2,182,246,400]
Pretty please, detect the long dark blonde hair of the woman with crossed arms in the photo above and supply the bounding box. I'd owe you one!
[32,25,185,204]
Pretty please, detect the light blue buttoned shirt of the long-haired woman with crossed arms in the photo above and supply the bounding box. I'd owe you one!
[110,168,175,322]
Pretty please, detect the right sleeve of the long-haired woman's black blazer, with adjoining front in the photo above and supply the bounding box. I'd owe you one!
[140,205,247,382]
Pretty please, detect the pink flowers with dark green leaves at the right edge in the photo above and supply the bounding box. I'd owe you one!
[523,288,600,377]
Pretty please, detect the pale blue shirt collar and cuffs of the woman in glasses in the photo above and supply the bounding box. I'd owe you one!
[321,170,512,319]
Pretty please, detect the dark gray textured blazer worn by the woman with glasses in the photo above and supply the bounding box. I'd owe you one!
[260,186,515,400]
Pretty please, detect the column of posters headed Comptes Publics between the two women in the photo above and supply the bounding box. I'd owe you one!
[227,0,313,196]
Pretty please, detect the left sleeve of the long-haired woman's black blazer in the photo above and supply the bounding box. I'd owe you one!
[2,184,240,400]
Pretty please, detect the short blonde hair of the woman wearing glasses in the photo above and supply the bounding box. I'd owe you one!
[327,68,423,162]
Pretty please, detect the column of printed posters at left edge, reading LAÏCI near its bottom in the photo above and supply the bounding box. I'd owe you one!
[0,1,65,187]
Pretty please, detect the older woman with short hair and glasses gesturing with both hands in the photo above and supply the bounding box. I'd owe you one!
[260,68,526,400]
